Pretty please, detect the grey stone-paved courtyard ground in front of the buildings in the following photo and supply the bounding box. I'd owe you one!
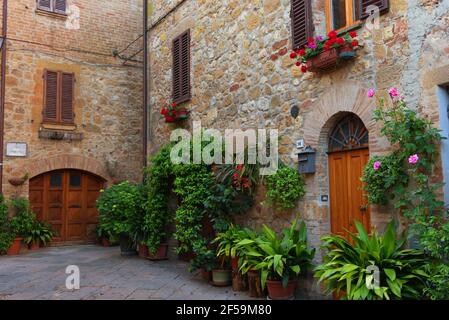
[0,246,256,300]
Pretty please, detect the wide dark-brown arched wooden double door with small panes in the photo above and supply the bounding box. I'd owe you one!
[30,170,105,243]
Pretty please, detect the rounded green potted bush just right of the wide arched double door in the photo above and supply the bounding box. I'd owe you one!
[97,181,143,256]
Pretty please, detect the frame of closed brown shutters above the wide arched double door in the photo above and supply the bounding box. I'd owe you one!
[42,69,76,126]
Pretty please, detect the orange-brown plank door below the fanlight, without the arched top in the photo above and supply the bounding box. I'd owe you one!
[329,149,370,238]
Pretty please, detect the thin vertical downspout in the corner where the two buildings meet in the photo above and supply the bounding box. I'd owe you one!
[142,0,149,167]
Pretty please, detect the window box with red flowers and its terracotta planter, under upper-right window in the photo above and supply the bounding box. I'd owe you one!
[290,31,359,73]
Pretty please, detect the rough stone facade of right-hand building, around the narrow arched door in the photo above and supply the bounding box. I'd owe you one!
[149,0,449,254]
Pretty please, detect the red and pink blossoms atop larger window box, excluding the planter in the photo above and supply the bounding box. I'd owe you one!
[290,31,359,73]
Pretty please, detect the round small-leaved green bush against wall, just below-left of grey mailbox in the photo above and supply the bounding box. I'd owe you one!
[265,166,306,210]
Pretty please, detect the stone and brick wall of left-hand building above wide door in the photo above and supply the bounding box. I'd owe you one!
[3,0,142,197]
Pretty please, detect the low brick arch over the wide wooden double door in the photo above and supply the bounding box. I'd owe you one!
[25,154,112,184]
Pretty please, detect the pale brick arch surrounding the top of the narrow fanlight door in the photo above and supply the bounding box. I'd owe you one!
[304,81,376,148]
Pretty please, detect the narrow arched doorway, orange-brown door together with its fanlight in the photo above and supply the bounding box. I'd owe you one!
[328,113,370,237]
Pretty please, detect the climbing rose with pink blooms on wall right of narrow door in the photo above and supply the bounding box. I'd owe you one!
[362,88,449,299]
